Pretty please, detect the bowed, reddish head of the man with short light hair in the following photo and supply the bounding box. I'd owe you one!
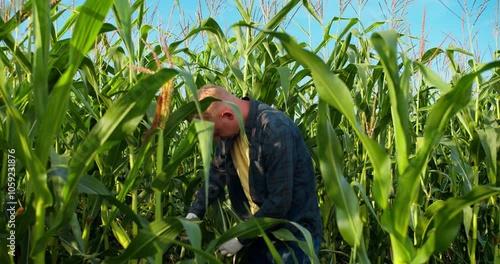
[195,84,250,140]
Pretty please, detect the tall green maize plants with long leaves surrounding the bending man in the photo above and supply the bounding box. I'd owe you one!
[0,0,500,264]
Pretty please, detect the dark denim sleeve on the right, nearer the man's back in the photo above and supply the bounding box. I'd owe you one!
[254,118,295,218]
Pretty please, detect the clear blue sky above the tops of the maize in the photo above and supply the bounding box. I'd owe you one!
[147,0,500,61]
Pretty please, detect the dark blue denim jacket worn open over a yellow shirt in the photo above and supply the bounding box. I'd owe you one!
[189,98,323,243]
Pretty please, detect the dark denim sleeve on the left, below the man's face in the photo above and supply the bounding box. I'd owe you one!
[189,143,228,218]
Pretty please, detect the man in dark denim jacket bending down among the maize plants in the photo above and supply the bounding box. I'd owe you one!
[186,85,322,263]
